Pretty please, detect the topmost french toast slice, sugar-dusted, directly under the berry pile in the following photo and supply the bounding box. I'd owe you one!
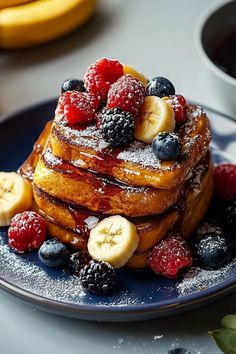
[49,105,211,189]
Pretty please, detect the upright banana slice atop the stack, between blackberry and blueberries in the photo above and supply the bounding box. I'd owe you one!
[135,96,175,144]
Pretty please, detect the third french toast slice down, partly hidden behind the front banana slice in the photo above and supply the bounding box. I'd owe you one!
[31,154,212,253]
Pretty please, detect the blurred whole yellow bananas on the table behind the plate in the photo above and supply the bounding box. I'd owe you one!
[0,0,96,49]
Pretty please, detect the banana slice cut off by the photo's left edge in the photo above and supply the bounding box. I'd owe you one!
[0,172,33,226]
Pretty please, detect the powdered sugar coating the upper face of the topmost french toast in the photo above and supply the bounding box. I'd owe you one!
[52,105,210,171]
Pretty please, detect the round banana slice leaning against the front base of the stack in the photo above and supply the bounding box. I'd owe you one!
[88,215,139,268]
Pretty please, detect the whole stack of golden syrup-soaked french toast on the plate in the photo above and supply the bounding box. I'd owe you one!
[19,58,213,268]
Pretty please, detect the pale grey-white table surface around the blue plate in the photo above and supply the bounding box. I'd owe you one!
[0,0,236,354]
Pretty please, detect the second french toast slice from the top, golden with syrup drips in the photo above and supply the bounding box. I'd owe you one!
[33,147,186,217]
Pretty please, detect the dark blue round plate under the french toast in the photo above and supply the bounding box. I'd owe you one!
[0,100,236,321]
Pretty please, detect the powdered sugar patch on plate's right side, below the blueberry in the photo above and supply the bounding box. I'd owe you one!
[177,258,236,296]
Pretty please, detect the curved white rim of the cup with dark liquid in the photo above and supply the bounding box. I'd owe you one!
[195,0,236,86]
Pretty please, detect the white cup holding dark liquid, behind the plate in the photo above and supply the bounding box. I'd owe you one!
[196,1,236,119]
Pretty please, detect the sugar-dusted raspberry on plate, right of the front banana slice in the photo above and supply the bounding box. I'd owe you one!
[148,234,192,278]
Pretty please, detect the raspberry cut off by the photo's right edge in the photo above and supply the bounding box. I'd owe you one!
[214,163,236,202]
